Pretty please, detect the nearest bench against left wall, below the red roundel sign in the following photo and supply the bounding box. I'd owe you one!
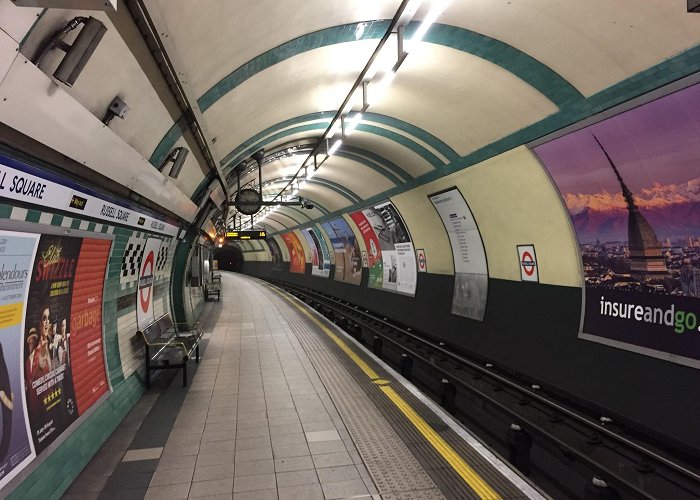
[136,314,203,388]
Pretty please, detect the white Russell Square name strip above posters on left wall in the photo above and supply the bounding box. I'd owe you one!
[0,156,178,236]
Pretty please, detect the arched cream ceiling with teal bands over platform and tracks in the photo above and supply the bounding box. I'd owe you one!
[141,0,700,230]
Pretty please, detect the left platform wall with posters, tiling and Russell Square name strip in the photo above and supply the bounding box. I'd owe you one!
[0,149,194,498]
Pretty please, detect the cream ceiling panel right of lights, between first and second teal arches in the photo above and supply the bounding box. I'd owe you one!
[369,45,558,155]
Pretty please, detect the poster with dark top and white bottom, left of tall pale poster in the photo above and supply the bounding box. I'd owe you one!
[372,201,418,295]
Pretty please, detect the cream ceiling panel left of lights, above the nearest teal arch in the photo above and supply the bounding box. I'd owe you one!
[146,0,401,96]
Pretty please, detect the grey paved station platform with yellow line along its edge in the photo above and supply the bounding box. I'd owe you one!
[63,273,547,500]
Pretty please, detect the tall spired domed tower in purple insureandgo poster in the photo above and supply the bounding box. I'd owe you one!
[593,135,668,281]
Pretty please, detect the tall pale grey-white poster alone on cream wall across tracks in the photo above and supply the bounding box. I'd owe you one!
[429,188,489,321]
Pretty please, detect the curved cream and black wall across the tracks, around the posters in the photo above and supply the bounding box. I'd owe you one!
[240,123,700,450]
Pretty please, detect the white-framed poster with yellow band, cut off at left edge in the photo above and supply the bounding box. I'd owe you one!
[0,231,39,488]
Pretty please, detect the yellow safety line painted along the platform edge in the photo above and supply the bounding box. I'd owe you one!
[271,288,502,500]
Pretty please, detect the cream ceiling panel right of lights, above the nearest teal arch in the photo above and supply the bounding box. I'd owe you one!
[446,0,700,96]
